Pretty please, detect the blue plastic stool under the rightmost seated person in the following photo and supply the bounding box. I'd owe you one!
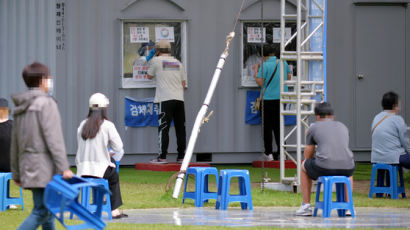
[369,163,406,199]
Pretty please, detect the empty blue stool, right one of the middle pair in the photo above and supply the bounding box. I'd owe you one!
[215,169,253,210]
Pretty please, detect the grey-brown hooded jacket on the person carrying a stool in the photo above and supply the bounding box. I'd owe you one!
[10,89,69,188]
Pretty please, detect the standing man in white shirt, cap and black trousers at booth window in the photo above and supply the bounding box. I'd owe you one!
[148,40,186,164]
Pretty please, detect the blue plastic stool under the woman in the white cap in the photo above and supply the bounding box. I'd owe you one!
[81,178,112,220]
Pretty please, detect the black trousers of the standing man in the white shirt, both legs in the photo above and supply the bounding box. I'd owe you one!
[158,100,186,159]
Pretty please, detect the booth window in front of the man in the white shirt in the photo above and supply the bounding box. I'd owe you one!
[121,20,186,88]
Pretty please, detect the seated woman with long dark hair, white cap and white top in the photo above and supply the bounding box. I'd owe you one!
[75,93,127,219]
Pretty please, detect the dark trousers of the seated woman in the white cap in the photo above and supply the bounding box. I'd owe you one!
[83,158,122,210]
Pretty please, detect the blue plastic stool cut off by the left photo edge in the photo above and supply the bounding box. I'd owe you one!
[0,173,24,211]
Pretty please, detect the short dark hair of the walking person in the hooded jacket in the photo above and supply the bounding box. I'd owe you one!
[22,62,49,87]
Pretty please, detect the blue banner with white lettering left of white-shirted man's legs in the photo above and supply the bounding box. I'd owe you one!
[124,97,158,127]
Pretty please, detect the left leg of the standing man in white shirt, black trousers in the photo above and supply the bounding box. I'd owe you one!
[158,101,172,159]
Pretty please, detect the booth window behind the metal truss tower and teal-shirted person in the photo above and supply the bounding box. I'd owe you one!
[241,21,296,87]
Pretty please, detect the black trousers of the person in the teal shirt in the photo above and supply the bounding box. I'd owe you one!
[263,100,280,157]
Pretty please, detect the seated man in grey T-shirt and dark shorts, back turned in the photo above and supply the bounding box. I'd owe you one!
[296,102,355,216]
